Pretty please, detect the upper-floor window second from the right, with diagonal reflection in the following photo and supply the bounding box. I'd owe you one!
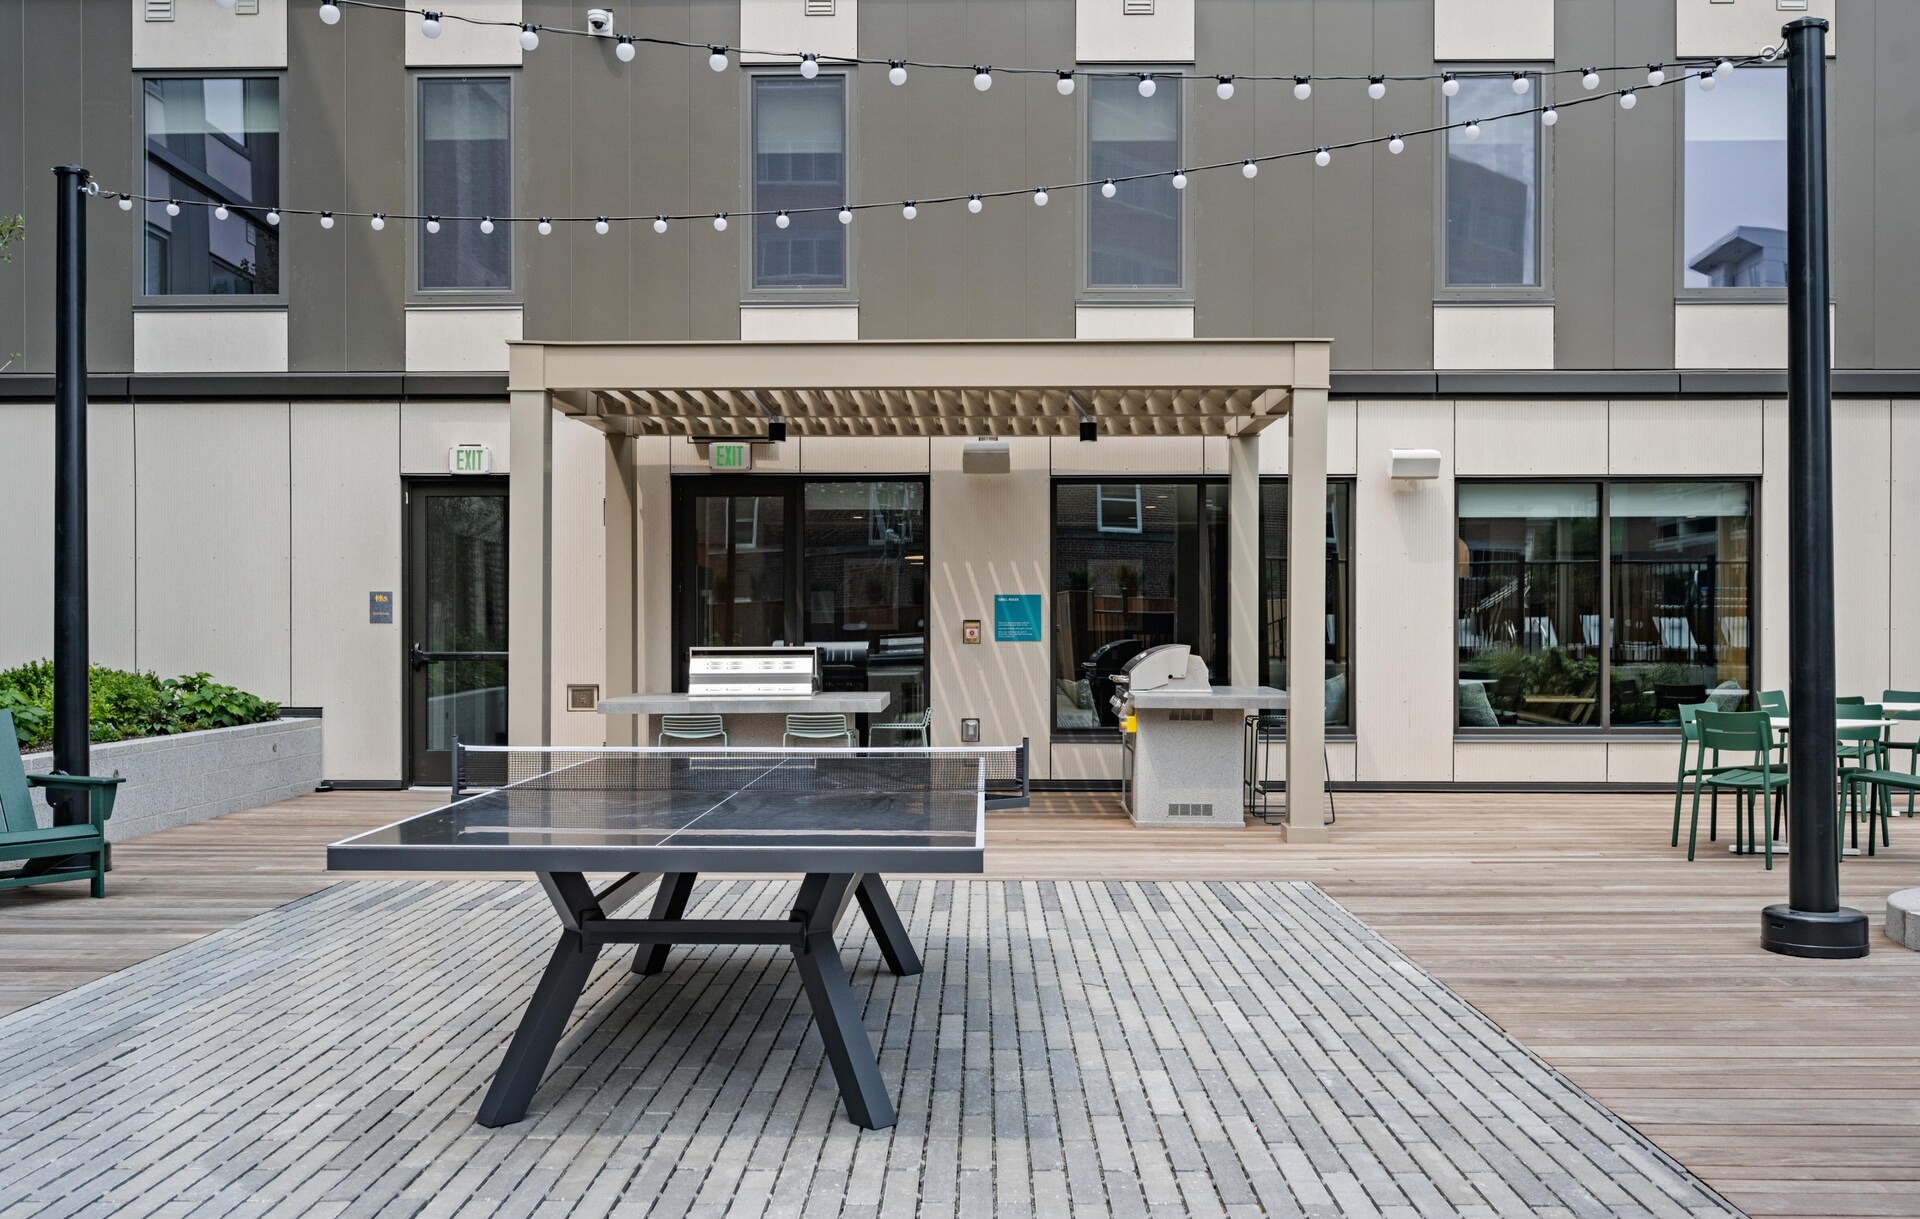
[1446,75,1540,288]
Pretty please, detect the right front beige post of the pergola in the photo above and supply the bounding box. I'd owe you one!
[1286,388,1327,843]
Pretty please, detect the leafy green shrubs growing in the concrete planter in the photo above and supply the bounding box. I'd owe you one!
[0,660,280,749]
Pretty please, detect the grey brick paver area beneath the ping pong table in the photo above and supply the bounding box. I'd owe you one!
[0,881,1736,1219]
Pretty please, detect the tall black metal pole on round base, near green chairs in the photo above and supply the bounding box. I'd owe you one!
[1761,17,1866,956]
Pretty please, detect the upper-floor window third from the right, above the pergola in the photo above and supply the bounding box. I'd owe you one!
[1087,77,1181,288]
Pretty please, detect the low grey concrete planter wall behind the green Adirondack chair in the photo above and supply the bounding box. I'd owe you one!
[25,718,321,843]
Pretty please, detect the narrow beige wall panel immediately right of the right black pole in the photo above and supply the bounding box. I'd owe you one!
[1834,397,1889,699]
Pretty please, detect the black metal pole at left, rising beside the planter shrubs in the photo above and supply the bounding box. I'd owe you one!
[54,165,90,825]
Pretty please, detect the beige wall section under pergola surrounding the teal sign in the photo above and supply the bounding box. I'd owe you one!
[927,438,1054,777]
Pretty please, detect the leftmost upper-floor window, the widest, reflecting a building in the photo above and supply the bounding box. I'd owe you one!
[144,77,280,296]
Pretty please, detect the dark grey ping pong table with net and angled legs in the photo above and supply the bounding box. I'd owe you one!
[326,747,1023,1129]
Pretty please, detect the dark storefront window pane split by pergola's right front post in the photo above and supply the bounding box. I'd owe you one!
[1260,478,1354,726]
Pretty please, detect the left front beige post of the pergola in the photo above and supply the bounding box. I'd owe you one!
[507,390,553,745]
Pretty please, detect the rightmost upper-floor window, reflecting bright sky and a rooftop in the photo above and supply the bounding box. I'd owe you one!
[1680,67,1788,288]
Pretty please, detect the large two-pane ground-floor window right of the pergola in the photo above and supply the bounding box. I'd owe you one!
[1457,482,1753,728]
